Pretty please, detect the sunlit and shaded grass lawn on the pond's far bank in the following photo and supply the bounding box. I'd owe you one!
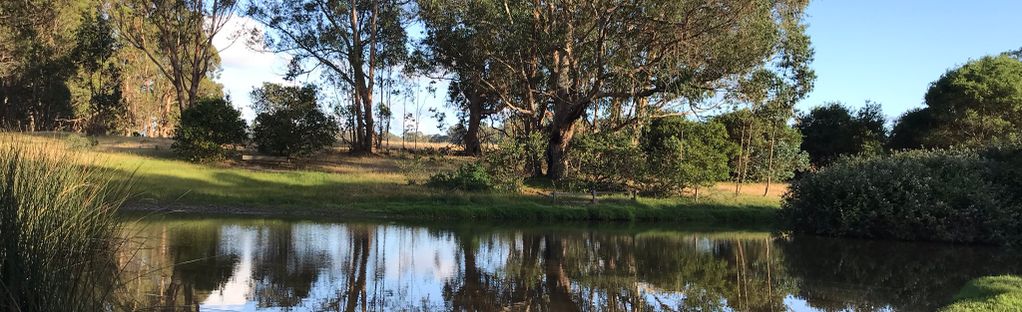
[6,133,784,224]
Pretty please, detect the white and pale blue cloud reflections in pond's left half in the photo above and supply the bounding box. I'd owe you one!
[194,224,458,311]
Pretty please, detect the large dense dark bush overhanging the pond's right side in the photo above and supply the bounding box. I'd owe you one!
[782,145,1022,244]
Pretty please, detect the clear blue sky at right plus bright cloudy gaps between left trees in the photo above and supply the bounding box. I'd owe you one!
[217,0,1022,133]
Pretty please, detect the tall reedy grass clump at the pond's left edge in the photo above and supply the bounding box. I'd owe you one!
[0,140,128,311]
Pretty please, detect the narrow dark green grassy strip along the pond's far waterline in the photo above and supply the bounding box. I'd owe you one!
[118,202,779,226]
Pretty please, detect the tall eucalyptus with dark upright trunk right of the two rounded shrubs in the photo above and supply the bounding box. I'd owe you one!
[245,0,408,153]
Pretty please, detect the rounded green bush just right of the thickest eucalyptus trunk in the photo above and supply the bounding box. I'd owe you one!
[567,132,646,190]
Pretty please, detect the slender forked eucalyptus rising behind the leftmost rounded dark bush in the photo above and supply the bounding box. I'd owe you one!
[114,0,237,112]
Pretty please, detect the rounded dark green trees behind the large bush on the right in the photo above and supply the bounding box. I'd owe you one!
[795,50,1022,167]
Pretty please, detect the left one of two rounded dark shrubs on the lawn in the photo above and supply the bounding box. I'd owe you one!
[171,98,247,162]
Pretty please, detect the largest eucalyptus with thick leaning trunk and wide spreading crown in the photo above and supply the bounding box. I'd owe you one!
[439,0,811,179]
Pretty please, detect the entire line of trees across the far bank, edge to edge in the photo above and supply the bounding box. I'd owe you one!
[9,0,1022,196]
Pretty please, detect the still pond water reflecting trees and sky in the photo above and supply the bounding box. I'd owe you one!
[119,218,1022,311]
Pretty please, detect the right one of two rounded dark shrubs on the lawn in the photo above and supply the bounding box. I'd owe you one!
[252,107,338,158]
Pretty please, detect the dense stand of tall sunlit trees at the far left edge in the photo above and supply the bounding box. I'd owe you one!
[0,0,227,136]
